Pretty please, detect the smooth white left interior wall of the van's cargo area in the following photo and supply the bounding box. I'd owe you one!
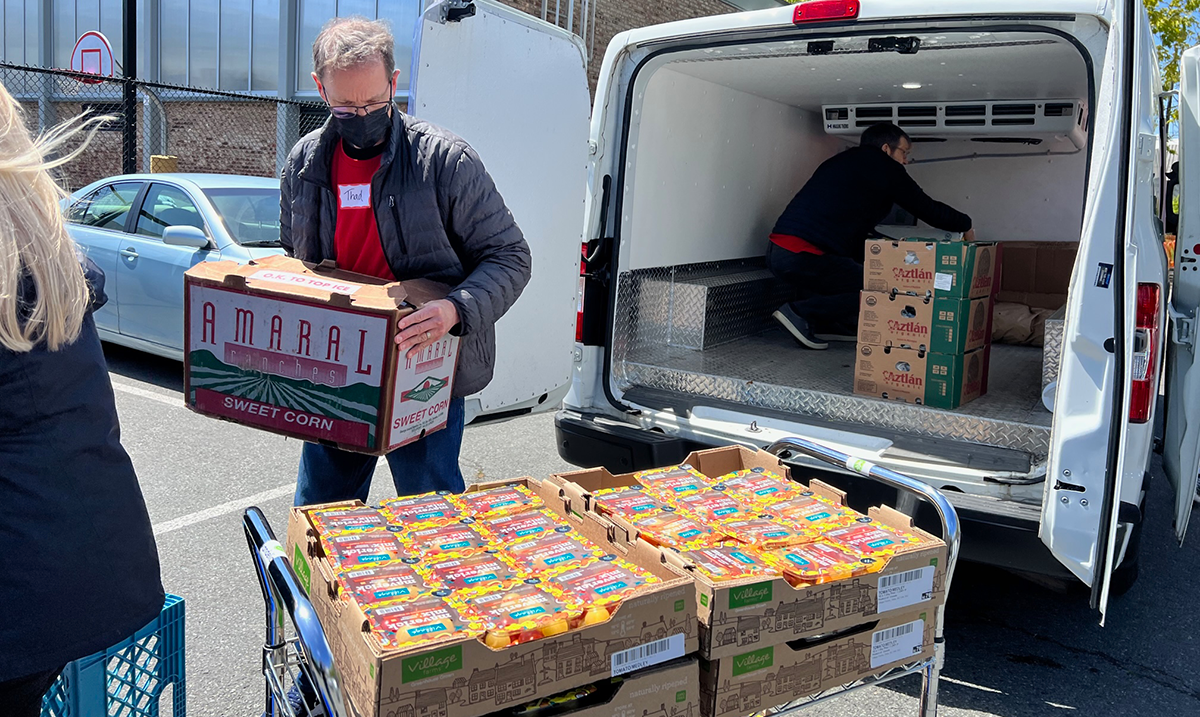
[623,68,850,269]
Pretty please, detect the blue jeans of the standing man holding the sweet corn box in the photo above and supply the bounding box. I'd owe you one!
[294,398,467,506]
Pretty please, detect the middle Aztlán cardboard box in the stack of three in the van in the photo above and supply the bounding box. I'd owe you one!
[858,291,991,354]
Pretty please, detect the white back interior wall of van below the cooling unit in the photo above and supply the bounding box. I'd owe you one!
[908,140,1087,241]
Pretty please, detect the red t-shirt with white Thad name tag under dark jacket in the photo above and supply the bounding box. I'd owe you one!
[331,141,396,282]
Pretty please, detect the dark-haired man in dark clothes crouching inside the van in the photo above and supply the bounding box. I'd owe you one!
[767,122,974,349]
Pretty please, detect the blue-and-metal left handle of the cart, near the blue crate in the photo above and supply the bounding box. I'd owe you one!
[242,507,347,717]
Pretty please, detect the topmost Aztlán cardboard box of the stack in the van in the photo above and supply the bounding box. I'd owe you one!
[863,239,1000,299]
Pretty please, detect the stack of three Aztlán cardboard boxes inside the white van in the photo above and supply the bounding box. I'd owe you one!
[854,237,1000,409]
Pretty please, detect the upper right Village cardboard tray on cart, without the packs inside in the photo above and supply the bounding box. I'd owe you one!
[542,446,948,659]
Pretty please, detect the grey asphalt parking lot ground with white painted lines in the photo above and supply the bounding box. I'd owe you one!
[106,347,1200,717]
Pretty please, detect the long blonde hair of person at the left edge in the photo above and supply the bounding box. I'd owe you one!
[0,85,110,353]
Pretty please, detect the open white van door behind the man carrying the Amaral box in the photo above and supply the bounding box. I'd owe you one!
[408,0,592,420]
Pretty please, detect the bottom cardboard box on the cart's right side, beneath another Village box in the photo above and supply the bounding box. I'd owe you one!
[700,610,936,717]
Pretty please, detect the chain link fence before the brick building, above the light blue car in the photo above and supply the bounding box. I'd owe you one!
[0,62,329,191]
